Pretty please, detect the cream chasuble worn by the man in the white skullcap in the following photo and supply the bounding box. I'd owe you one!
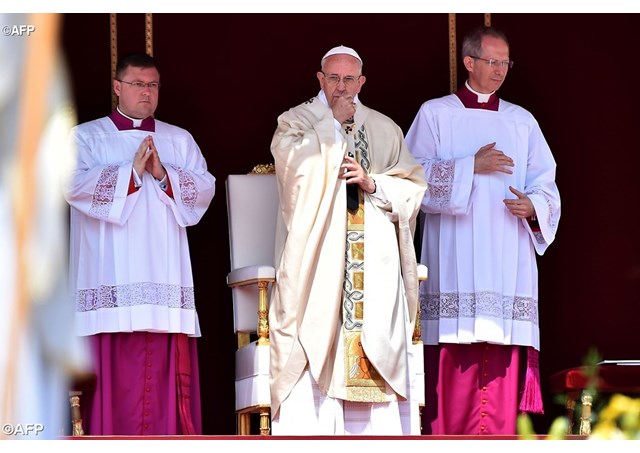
[269,97,426,416]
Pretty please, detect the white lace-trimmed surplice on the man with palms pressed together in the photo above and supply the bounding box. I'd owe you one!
[66,117,215,336]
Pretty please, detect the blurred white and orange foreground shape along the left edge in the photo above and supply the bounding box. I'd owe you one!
[0,14,88,439]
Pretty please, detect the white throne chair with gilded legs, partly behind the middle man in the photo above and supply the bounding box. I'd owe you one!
[226,165,278,435]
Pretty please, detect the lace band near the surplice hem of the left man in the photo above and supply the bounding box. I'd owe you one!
[76,282,196,312]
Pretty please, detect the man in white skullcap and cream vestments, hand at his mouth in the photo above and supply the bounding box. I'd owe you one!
[269,46,425,434]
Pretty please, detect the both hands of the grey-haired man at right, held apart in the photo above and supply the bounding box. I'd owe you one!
[473,142,536,219]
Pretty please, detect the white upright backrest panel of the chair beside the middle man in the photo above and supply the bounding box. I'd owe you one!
[227,174,278,269]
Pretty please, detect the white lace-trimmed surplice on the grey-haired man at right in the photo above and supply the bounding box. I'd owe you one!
[406,95,560,349]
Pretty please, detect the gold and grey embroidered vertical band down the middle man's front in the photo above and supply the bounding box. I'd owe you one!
[342,122,388,402]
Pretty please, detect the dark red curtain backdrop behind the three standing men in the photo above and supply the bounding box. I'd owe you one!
[63,13,640,435]
